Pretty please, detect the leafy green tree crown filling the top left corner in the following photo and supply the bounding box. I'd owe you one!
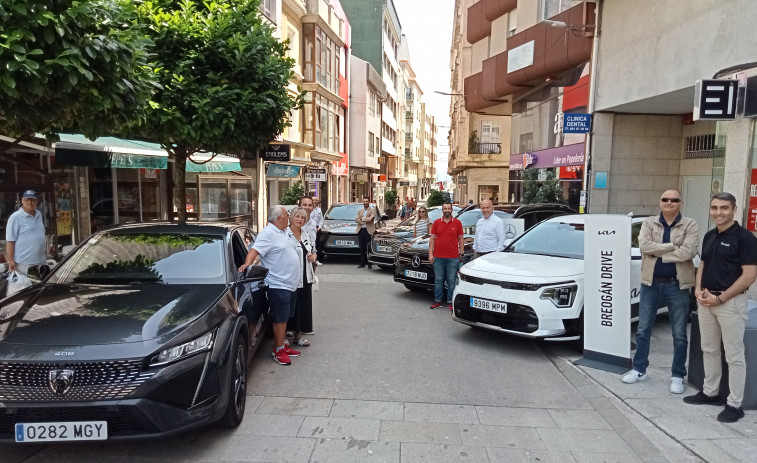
[0,0,157,150]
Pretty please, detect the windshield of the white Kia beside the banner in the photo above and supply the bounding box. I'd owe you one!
[507,222,584,259]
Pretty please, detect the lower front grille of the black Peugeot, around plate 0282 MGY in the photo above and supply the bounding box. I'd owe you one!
[0,406,160,440]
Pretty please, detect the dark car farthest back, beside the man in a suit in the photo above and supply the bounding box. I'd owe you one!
[319,203,389,256]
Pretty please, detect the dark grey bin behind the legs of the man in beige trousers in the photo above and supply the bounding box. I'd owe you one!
[687,301,757,410]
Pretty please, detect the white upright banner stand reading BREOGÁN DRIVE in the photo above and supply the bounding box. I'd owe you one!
[576,214,631,373]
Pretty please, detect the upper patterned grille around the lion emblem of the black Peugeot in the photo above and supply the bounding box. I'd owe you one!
[0,360,155,402]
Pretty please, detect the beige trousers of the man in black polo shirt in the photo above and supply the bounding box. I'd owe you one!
[699,294,747,408]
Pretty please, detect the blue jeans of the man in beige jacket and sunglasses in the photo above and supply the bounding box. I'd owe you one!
[633,281,690,378]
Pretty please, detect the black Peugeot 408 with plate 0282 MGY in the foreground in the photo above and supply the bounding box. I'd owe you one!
[0,224,269,442]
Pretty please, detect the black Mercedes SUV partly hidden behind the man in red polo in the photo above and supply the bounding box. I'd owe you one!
[394,204,575,291]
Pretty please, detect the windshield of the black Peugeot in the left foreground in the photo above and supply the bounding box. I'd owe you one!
[48,232,226,285]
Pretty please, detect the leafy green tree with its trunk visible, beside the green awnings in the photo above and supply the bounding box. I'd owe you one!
[131,0,304,222]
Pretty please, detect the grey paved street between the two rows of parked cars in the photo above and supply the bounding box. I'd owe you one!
[0,259,699,463]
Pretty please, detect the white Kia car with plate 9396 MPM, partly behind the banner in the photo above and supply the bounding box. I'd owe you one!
[452,214,656,348]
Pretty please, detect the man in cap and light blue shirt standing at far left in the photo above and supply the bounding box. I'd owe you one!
[5,190,46,274]
